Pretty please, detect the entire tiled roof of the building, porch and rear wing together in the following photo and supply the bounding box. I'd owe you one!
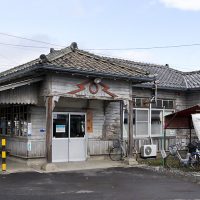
[0,43,200,90]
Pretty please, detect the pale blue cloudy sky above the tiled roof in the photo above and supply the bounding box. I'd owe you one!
[0,0,200,71]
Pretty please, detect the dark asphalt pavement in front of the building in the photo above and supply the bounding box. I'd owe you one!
[0,167,200,200]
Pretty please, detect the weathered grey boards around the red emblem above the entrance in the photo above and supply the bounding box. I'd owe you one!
[47,75,131,100]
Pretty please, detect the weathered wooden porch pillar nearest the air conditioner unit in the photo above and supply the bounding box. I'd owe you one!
[127,100,133,158]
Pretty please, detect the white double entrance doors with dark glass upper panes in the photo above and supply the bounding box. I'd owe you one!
[52,112,86,162]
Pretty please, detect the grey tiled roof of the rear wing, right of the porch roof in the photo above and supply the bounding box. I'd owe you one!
[104,58,200,90]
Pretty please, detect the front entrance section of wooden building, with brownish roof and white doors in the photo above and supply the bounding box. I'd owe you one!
[0,43,155,162]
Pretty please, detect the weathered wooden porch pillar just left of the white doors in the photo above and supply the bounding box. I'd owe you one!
[46,97,54,163]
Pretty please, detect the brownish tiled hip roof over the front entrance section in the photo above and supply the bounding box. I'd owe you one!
[0,43,153,82]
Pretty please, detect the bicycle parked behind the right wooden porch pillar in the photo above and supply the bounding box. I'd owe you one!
[109,139,137,161]
